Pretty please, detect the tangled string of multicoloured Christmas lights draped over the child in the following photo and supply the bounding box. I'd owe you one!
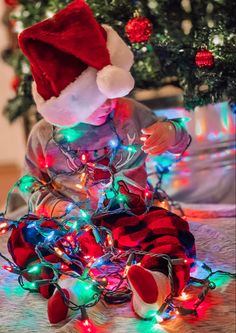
[0,113,235,328]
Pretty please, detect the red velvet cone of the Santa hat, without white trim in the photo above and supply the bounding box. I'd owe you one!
[19,0,110,100]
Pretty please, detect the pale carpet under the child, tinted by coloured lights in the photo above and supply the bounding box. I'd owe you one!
[0,205,236,333]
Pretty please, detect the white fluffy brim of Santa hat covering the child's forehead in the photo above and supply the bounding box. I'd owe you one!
[32,67,107,126]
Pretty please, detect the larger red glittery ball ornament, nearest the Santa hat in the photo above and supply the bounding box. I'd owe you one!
[125,17,153,43]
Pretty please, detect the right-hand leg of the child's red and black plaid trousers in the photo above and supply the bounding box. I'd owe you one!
[99,208,196,296]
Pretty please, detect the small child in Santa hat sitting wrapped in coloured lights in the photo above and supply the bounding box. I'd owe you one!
[11,0,194,323]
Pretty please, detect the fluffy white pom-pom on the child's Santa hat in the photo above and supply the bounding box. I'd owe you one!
[97,65,134,98]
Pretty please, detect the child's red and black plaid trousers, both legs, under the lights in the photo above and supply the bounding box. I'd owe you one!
[8,208,196,298]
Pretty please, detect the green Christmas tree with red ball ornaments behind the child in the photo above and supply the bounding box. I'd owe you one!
[3,0,236,121]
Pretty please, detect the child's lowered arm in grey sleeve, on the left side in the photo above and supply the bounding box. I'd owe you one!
[24,121,77,217]
